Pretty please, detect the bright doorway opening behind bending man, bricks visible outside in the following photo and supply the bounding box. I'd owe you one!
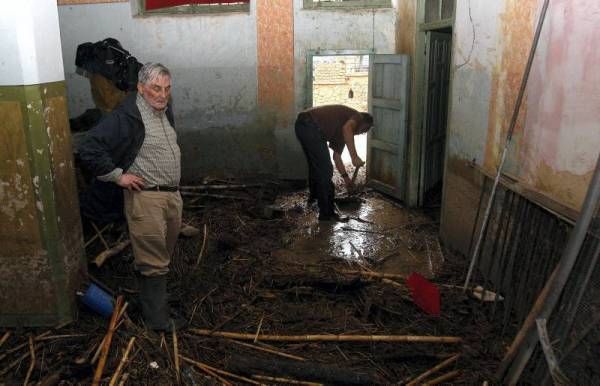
[309,52,369,170]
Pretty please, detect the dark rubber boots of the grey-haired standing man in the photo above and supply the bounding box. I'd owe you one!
[140,275,185,331]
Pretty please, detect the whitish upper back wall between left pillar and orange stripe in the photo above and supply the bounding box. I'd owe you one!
[59,3,256,130]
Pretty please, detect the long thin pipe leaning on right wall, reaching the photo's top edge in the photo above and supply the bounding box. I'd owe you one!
[463,0,550,291]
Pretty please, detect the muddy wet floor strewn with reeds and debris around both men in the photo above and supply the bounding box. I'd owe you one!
[0,180,506,385]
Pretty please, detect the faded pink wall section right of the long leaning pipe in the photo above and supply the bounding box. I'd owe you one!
[519,0,600,208]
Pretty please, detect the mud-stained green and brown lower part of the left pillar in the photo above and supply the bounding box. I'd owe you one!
[0,82,86,326]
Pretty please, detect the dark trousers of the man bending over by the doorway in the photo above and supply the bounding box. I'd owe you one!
[295,113,335,216]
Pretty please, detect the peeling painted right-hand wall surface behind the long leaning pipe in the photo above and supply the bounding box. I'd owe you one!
[441,0,600,252]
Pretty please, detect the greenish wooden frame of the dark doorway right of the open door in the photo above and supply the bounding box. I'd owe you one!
[406,0,458,207]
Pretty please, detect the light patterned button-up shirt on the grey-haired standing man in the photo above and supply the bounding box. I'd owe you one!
[127,94,181,187]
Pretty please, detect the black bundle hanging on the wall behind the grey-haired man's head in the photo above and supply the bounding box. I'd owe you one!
[75,38,142,91]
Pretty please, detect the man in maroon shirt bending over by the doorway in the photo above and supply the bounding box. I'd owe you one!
[295,105,373,221]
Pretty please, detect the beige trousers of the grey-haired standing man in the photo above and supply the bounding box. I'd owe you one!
[124,190,183,276]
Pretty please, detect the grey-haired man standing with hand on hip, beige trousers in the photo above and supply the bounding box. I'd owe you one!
[79,63,183,330]
